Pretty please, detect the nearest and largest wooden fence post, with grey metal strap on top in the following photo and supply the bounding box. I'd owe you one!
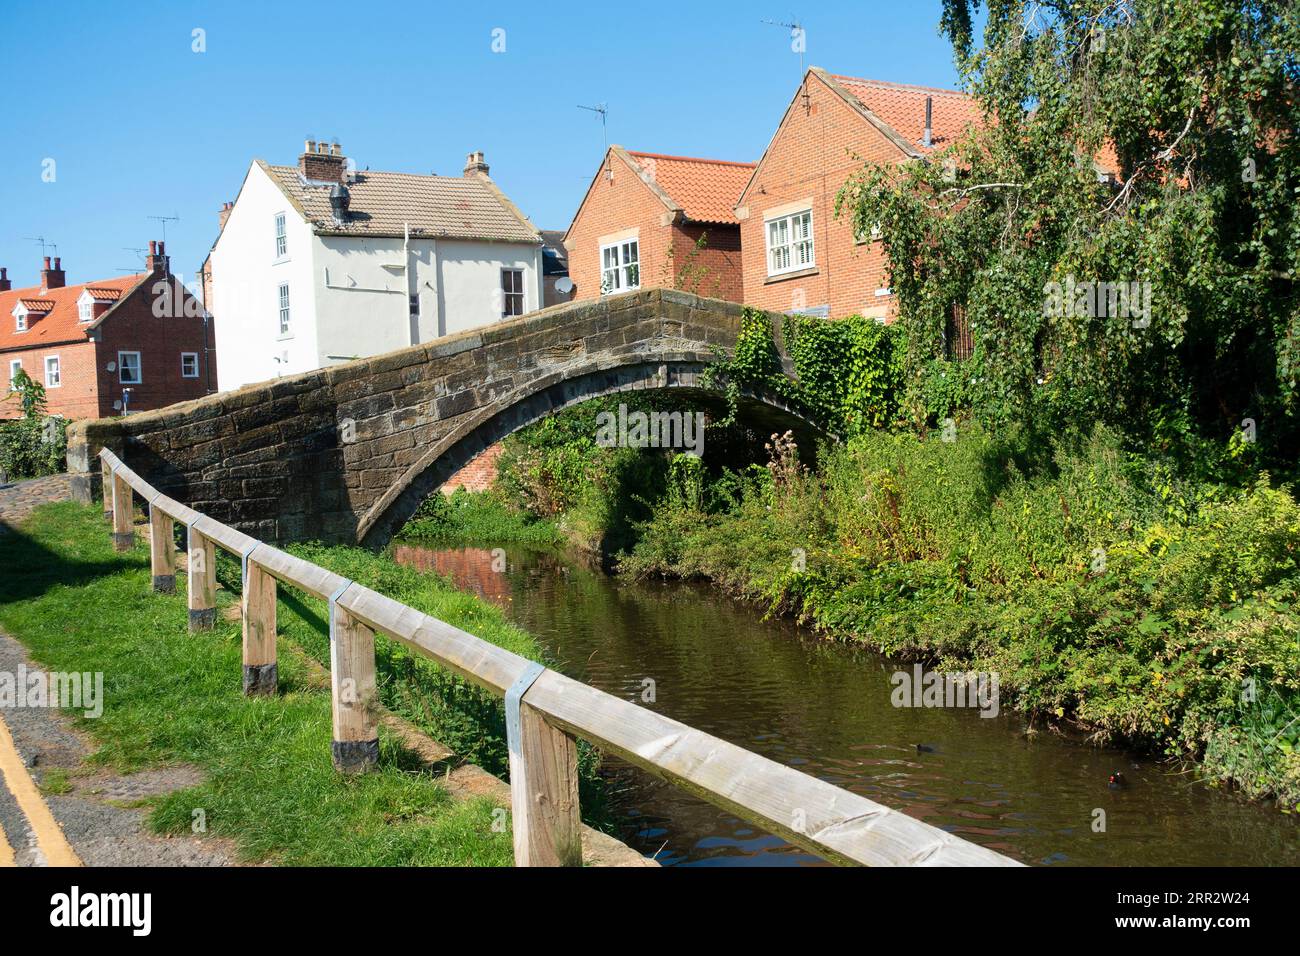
[506,663,582,866]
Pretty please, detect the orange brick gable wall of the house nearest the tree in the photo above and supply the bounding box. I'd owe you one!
[741,74,905,317]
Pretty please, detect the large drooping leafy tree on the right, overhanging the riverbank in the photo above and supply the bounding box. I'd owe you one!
[837,0,1300,463]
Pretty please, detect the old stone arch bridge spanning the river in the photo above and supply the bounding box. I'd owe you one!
[68,289,815,545]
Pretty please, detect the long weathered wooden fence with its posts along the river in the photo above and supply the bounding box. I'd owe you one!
[100,449,1021,866]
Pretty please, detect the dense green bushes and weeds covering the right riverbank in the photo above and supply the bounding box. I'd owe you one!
[620,427,1300,805]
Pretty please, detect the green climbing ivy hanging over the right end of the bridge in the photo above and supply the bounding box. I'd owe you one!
[705,307,902,436]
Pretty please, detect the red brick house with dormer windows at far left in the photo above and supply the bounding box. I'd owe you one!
[0,242,217,419]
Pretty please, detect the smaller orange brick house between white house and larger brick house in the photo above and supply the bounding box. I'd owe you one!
[564,146,754,302]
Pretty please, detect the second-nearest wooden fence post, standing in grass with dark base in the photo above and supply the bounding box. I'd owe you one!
[329,581,380,774]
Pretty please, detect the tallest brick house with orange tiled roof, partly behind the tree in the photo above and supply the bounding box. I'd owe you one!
[736,66,980,321]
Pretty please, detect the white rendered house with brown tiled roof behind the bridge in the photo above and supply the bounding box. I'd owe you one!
[203,140,542,389]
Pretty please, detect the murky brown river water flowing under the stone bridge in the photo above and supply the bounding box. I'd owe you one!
[394,542,1300,866]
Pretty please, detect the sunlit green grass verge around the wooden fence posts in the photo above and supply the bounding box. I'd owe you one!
[0,503,522,865]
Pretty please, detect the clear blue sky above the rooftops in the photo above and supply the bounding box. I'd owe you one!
[0,0,956,286]
